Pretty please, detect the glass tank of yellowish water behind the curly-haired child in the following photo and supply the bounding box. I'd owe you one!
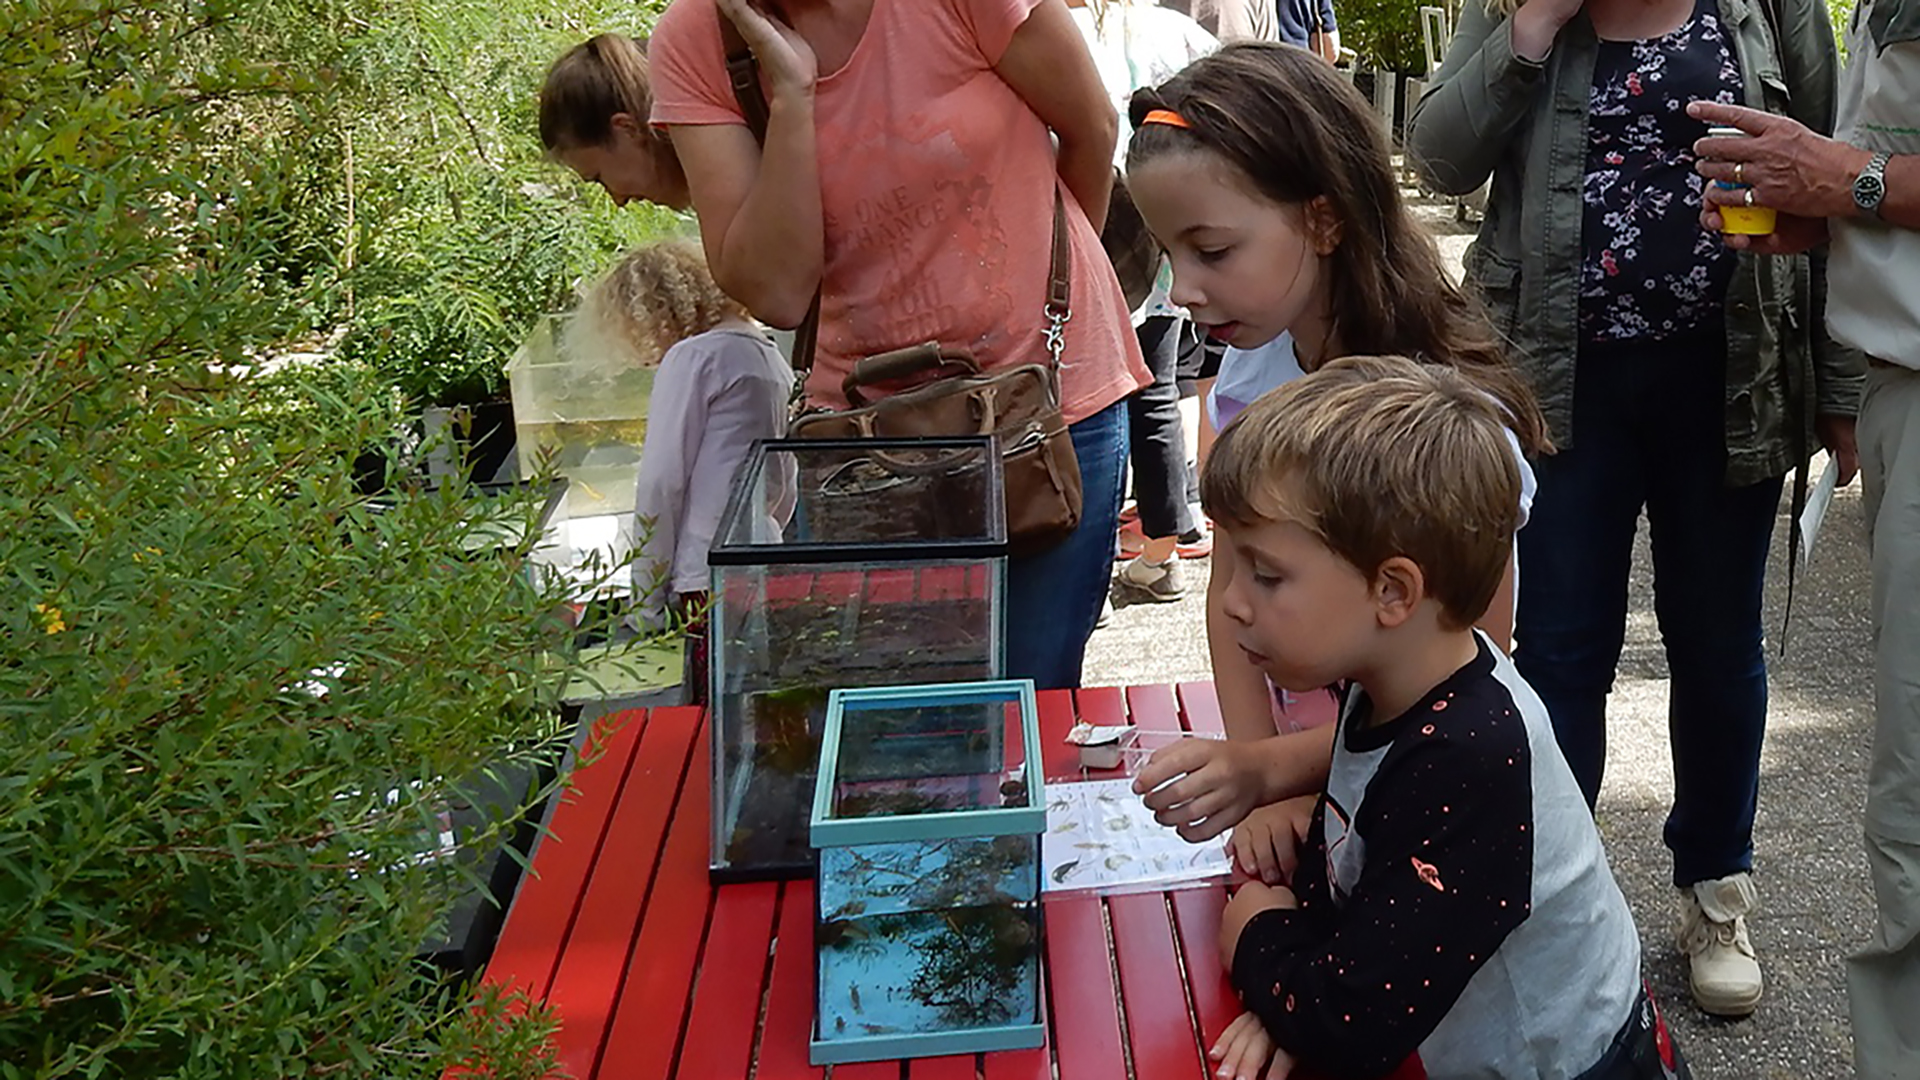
[507,315,653,519]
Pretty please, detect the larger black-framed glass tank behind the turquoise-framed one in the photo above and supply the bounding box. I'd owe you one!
[707,436,1006,880]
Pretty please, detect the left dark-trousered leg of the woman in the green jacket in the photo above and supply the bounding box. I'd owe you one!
[1513,340,1647,805]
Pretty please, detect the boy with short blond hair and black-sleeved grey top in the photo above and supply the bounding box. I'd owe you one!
[1190,357,1688,1080]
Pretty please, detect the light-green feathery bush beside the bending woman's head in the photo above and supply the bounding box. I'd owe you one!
[326,0,687,405]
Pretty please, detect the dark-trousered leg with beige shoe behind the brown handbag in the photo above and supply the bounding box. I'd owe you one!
[1119,315,1194,601]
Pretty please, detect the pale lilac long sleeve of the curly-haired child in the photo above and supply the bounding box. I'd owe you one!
[632,338,708,628]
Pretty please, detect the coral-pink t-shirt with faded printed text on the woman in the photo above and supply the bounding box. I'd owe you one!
[647,0,1152,423]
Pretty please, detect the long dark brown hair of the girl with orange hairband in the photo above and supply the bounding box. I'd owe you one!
[1127,42,1551,454]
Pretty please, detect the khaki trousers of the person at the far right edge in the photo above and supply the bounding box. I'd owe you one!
[1847,367,1920,1080]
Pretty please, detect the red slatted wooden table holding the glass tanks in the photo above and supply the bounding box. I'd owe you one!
[472,682,1328,1080]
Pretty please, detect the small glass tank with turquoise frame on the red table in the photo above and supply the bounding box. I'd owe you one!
[808,680,1046,1065]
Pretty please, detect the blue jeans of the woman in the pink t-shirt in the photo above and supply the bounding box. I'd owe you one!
[1006,402,1127,690]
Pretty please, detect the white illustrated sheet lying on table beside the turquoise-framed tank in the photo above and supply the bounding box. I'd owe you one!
[1041,778,1231,892]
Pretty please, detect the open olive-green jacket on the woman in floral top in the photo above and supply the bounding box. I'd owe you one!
[1407,0,1866,486]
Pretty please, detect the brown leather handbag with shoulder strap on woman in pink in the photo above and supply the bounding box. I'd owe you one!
[720,13,1081,555]
